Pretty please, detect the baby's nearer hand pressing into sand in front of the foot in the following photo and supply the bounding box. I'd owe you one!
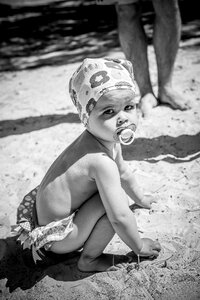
[138,238,161,257]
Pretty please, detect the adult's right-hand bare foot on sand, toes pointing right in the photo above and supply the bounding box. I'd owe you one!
[158,87,190,110]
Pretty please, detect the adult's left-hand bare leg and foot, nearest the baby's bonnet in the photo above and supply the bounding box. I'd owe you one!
[116,2,157,116]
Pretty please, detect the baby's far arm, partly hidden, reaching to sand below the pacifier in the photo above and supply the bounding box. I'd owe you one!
[116,145,156,208]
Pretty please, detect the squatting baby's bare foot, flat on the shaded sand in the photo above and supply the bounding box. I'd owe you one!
[78,254,118,272]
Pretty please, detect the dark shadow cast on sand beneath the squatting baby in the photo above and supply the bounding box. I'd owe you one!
[0,236,133,293]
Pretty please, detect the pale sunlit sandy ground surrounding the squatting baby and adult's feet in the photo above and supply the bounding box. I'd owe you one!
[0,18,200,300]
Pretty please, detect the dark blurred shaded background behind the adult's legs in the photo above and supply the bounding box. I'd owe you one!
[0,0,200,71]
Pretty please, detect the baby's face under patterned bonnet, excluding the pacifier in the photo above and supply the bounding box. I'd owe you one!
[87,90,138,142]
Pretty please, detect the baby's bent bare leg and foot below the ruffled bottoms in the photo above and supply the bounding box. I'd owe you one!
[51,194,115,272]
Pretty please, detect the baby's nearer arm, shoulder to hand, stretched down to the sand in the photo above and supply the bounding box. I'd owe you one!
[90,155,160,256]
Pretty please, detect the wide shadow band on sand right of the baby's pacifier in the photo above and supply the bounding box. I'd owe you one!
[123,133,200,163]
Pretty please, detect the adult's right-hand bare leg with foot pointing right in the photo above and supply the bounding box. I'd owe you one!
[152,0,188,110]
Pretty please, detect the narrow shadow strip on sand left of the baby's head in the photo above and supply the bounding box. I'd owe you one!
[0,113,80,138]
